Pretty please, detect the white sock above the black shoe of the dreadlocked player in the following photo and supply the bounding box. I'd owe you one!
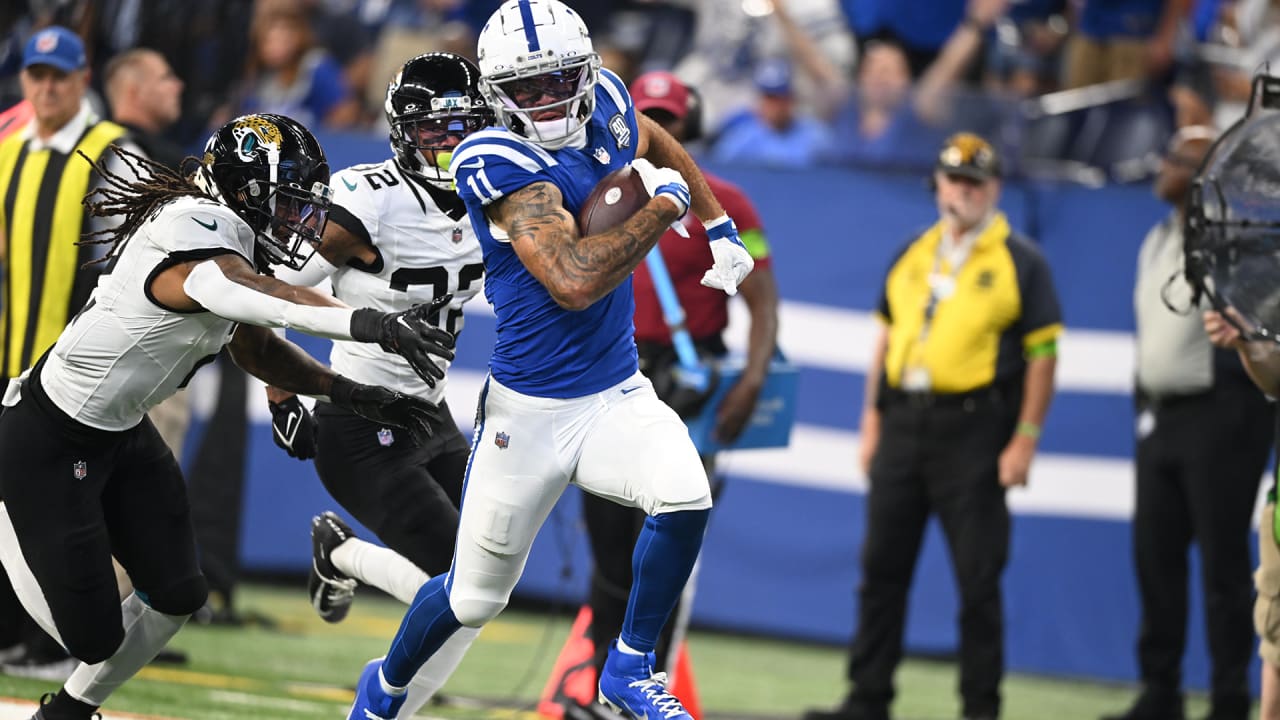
[64,594,188,706]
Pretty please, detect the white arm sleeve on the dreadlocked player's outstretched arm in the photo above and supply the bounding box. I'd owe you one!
[182,261,355,340]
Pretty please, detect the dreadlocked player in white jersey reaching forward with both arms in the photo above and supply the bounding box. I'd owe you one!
[0,114,453,720]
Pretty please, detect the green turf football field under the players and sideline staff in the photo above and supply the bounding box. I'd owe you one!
[0,585,1206,720]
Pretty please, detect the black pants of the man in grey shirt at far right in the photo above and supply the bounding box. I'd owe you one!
[1133,380,1274,717]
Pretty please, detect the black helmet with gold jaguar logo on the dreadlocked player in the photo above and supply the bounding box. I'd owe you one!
[196,113,333,269]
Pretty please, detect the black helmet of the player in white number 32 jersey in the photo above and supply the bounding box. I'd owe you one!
[384,53,494,190]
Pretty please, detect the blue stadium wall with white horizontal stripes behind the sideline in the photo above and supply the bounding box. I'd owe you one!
[192,130,1256,692]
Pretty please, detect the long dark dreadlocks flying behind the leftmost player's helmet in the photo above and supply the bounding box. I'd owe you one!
[76,145,218,265]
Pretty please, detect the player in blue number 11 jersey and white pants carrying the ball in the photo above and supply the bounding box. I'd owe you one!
[348,0,753,720]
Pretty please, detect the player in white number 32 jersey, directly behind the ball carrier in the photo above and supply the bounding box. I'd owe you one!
[268,53,493,717]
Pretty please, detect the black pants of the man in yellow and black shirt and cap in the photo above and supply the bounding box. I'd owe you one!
[849,396,1014,717]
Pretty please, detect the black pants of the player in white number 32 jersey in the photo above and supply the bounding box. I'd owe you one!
[315,394,470,577]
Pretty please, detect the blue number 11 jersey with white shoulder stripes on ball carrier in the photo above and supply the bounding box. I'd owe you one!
[449,70,639,397]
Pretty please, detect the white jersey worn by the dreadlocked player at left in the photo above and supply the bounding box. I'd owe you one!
[41,197,253,430]
